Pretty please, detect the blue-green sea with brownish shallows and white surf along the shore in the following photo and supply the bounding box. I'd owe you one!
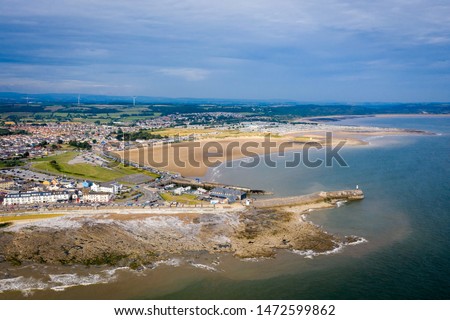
[0,116,450,299]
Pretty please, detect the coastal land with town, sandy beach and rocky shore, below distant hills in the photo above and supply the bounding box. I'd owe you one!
[0,99,442,300]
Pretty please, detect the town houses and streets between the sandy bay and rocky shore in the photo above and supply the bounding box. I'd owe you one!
[0,113,272,212]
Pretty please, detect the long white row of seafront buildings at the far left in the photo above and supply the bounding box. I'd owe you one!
[3,191,72,206]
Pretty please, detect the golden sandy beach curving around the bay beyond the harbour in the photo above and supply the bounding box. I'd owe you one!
[115,125,432,177]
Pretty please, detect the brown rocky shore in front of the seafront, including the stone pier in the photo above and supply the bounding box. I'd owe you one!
[0,190,363,268]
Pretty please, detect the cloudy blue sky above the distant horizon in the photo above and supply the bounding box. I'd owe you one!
[0,0,450,102]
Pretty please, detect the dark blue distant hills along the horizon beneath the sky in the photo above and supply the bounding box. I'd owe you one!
[0,92,450,119]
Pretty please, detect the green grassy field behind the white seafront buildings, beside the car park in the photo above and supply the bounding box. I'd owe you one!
[32,151,158,181]
